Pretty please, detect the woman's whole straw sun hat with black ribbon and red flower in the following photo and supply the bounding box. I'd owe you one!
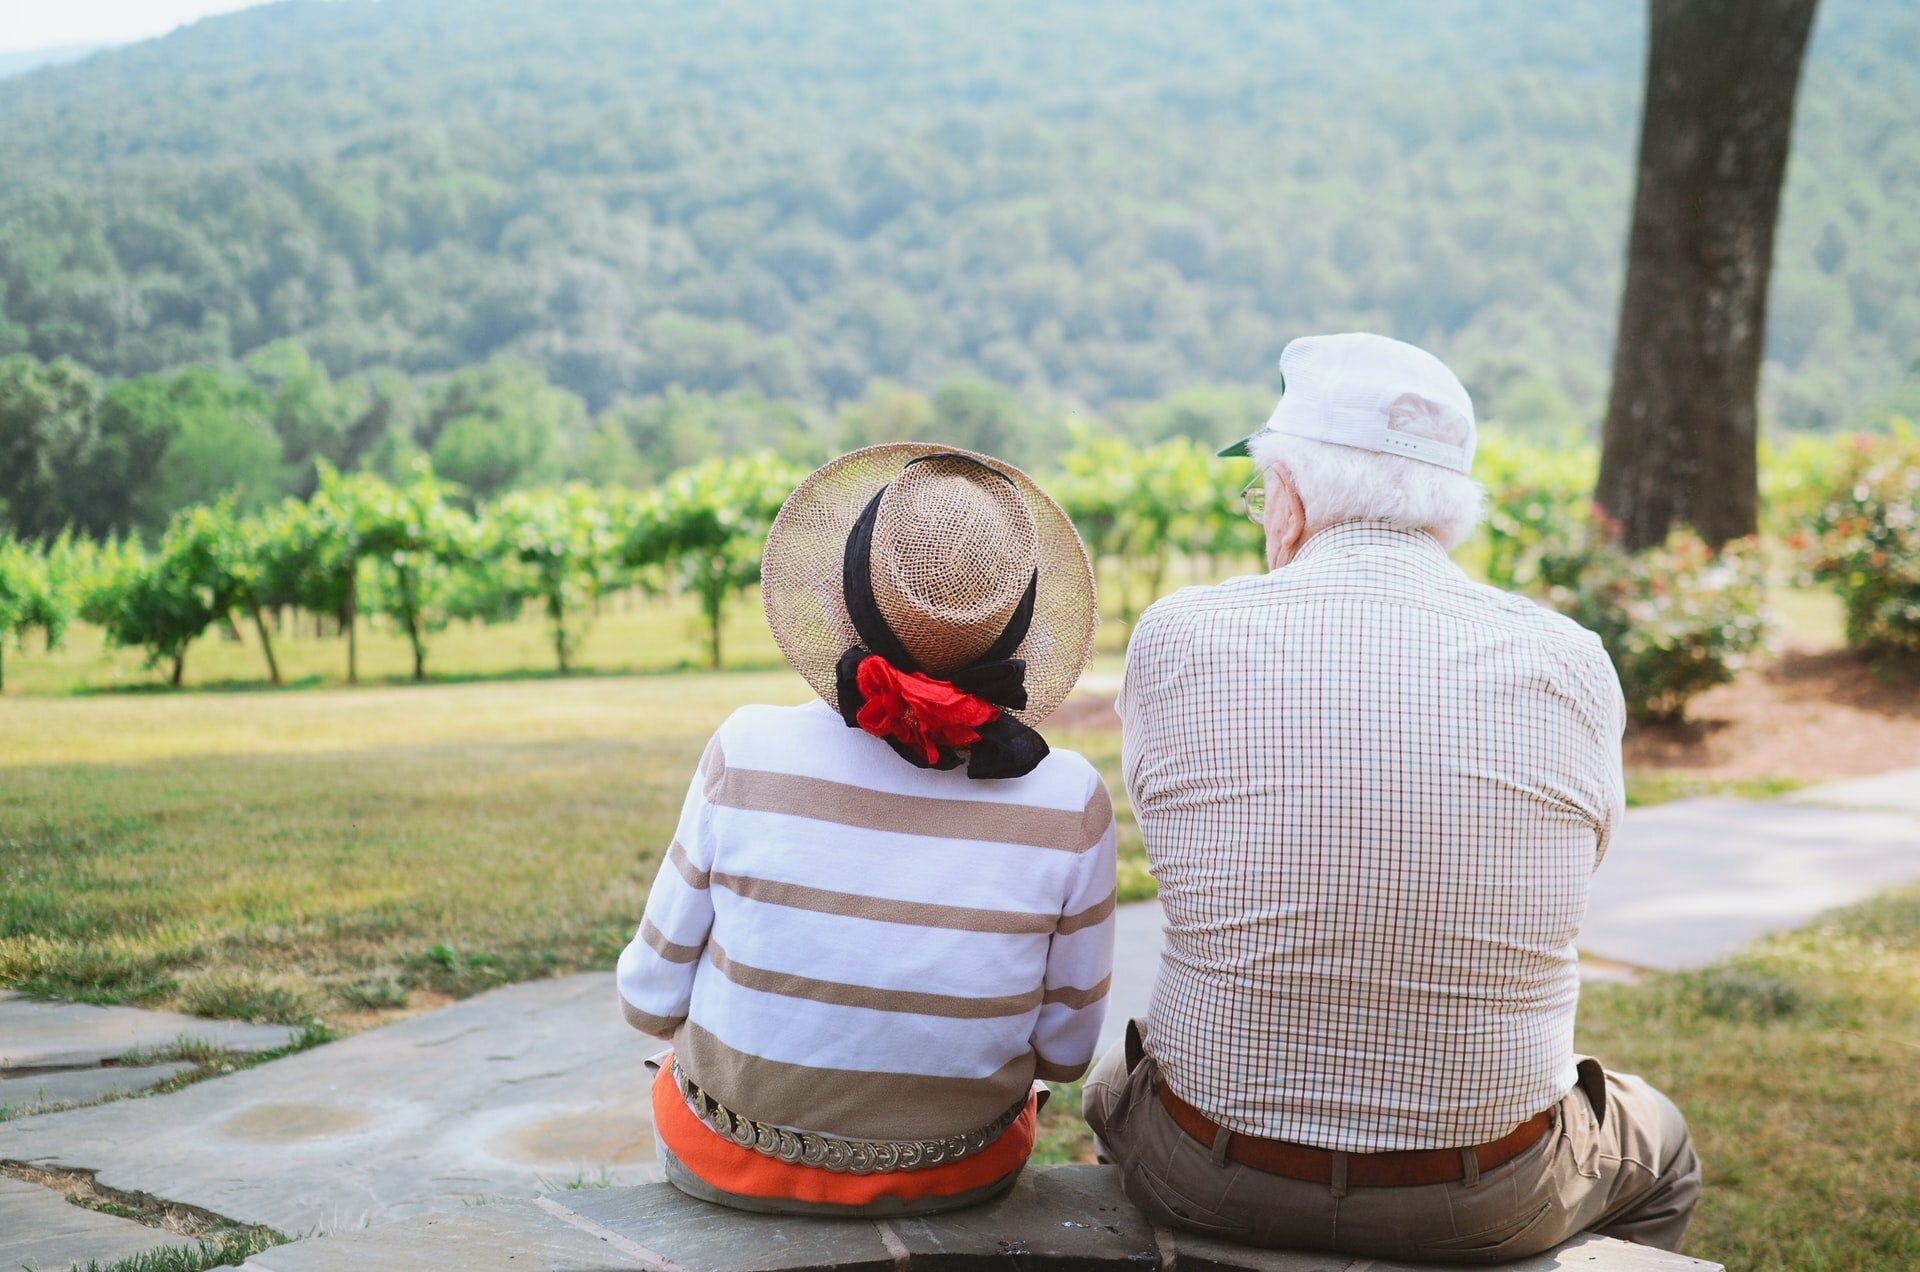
[760,442,1098,778]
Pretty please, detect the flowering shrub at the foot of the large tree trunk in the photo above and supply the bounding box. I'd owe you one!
[1540,509,1764,721]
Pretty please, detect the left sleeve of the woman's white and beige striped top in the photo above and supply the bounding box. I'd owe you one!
[614,734,726,1038]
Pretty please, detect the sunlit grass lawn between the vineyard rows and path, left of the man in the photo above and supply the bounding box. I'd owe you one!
[0,671,1152,1022]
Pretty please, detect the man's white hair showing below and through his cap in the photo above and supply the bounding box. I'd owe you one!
[1252,400,1486,551]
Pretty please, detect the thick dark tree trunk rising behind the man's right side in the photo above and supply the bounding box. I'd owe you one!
[1596,0,1816,550]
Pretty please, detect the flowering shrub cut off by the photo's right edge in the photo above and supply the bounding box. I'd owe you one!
[1797,421,1920,651]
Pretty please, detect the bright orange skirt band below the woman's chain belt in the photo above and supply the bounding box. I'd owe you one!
[653,1064,1039,1207]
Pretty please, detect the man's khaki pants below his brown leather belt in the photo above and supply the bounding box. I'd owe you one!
[1083,1022,1699,1262]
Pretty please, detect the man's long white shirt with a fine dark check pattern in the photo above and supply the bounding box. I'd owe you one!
[1119,521,1626,1153]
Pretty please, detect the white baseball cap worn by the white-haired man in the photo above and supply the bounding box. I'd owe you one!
[1219,330,1475,473]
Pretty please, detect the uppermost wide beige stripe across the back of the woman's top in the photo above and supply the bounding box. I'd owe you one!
[708,759,1112,853]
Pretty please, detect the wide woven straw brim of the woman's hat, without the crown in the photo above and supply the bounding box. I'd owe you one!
[760,442,1100,724]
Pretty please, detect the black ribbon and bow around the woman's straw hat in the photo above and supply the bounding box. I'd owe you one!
[833,455,1048,778]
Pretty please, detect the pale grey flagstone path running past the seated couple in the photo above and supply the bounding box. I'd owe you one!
[0,774,1920,1268]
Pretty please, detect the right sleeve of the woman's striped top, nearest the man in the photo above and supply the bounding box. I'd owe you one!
[1033,774,1116,1082]
